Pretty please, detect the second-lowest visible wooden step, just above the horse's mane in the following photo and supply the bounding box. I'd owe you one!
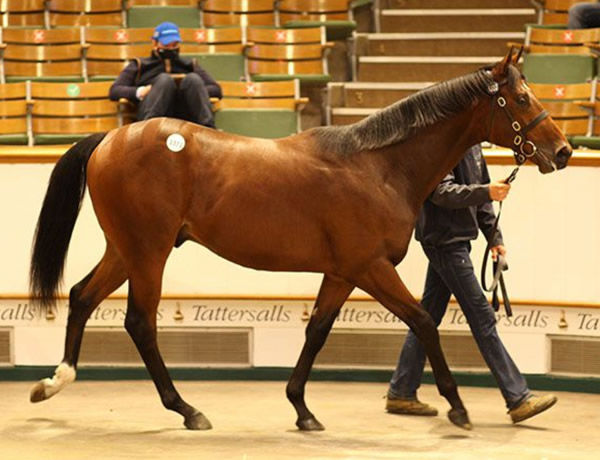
[327,82,433,109]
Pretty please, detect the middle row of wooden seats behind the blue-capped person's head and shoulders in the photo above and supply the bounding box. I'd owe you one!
[0,27,333,83]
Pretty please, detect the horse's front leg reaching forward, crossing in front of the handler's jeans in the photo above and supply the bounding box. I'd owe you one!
[357,259,471,430]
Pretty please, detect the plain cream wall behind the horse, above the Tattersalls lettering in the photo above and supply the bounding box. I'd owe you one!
[0,155,600,303]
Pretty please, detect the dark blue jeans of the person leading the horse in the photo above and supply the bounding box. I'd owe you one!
[389,243,529,409]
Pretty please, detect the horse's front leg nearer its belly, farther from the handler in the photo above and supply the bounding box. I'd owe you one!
[286,275,354,431]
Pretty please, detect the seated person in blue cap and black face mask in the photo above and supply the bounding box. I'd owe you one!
[109,22,222,128]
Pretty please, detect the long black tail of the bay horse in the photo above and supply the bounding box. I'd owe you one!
[29,133,106,308]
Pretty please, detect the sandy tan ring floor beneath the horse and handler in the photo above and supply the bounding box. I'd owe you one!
[0,381,600,460]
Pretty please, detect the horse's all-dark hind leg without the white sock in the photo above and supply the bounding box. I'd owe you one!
[125,262,212,430]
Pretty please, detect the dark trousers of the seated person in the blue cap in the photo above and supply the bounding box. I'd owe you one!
[137,73,215,128]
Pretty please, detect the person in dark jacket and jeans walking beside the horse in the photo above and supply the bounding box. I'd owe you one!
[386,145,556,423]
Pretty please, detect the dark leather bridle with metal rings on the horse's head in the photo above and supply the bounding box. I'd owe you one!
[487,79,548,166]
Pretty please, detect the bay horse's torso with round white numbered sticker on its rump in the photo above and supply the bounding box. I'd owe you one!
[88,119,410,272]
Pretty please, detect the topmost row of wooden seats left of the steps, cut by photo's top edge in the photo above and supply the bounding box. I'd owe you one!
[0,0,371,39]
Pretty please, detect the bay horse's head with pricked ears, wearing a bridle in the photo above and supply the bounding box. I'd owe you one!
[488,48,572,174]
